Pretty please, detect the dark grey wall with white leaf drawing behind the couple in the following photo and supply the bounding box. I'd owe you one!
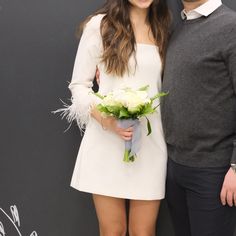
[0,0,236,236]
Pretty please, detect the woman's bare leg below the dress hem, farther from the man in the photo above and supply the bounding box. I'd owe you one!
[93,194,127,236]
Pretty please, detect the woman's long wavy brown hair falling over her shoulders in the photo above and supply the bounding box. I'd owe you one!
[80,0,170,77]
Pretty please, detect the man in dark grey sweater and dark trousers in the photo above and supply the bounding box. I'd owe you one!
[161,0,236,236]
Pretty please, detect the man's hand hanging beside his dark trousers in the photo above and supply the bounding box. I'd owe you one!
[220,168,236,207]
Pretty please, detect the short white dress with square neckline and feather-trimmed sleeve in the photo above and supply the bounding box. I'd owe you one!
[68,15,167,200]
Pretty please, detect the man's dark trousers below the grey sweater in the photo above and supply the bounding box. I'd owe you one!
[166,160,236,236]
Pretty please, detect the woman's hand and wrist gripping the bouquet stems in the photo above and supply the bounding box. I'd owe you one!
[101,117,133,141]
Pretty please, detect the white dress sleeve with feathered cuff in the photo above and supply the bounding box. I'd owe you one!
[56,16,102,130]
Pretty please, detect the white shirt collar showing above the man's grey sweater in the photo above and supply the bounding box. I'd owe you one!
[181,0,222,20]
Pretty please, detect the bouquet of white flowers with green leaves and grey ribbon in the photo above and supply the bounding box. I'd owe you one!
[95,86,167,162]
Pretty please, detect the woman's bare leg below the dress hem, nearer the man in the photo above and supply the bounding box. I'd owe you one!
[129,200,160,236]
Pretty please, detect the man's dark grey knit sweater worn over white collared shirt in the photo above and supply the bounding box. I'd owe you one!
[161,5,236,167]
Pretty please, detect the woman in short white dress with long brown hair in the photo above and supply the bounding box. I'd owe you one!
[59,0,169,236]
